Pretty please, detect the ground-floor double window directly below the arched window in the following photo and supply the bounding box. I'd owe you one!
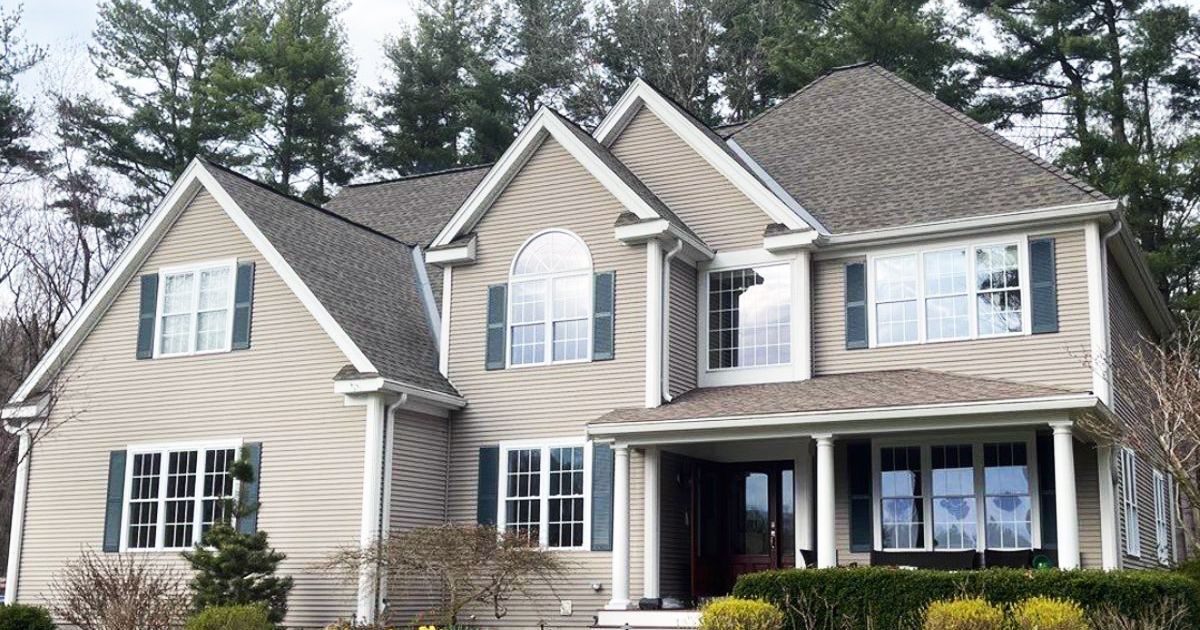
[500,444,588,548]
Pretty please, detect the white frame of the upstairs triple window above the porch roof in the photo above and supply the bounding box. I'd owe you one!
[866,234,1032,348]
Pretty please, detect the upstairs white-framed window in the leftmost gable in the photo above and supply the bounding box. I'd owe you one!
[156,260,235,356]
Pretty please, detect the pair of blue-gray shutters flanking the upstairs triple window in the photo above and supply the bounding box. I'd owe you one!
[845,238,1058,350]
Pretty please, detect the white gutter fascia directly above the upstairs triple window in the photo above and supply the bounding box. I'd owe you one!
[818,199,1120,252]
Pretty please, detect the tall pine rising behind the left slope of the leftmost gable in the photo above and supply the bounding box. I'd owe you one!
[59,0,252,211]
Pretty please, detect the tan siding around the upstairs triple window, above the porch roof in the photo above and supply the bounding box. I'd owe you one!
[812,228,1092,391]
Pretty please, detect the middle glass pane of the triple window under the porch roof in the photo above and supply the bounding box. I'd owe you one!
[931,444,977,550]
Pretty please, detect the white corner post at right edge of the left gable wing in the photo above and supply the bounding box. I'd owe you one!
[354,392,388,623]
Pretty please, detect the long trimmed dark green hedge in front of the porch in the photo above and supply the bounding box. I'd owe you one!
[733,566,1200,628]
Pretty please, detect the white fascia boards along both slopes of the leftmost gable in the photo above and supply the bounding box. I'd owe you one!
[11,160,376,403]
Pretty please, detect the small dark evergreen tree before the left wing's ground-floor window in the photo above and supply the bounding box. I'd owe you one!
[181,449,293,623]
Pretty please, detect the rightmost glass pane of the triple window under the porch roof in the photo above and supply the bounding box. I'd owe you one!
[983,442,1033,548]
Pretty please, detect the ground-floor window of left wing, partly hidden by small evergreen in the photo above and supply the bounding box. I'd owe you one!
[124,444,238,550]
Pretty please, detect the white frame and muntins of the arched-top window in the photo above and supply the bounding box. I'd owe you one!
[504,228,595,370]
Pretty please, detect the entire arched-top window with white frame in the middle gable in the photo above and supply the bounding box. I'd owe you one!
[509,229,592,365]
